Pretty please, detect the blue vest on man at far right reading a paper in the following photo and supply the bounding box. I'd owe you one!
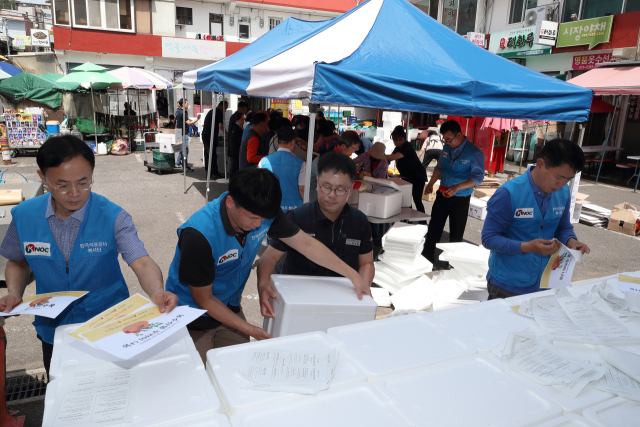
[489,171,569,288]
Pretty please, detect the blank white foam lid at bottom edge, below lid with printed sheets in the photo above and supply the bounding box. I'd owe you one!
[231,383,410,427]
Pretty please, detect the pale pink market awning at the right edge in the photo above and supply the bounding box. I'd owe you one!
[568,62,640,95]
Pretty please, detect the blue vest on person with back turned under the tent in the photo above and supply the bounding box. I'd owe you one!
[261,151,304,212]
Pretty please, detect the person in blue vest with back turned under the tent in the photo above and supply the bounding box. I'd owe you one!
[258,127,305,212]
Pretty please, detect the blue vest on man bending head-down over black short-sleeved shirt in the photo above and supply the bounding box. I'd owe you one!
[166,192,273,316]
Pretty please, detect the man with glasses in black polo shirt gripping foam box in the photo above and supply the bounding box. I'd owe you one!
[258,151,375,317]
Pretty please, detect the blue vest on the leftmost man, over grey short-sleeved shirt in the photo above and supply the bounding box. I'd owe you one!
[11,193,129,344]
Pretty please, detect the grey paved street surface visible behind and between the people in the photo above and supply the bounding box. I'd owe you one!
[0,142,640,426]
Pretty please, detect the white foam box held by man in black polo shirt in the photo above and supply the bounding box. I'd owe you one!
[264,274,378,337]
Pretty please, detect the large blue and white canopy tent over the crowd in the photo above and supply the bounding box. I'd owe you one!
[183,0,593,200]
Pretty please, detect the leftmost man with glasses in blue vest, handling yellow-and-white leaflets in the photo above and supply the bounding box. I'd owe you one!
[0,135,178,375]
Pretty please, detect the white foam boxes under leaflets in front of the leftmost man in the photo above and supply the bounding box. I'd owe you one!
[43,324,222,427]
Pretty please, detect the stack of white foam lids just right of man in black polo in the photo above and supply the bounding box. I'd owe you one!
[373,222,433,294]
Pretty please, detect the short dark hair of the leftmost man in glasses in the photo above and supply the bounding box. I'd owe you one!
[36,135,96,174]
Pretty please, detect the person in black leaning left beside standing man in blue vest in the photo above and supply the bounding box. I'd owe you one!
[385,126,427,213]
